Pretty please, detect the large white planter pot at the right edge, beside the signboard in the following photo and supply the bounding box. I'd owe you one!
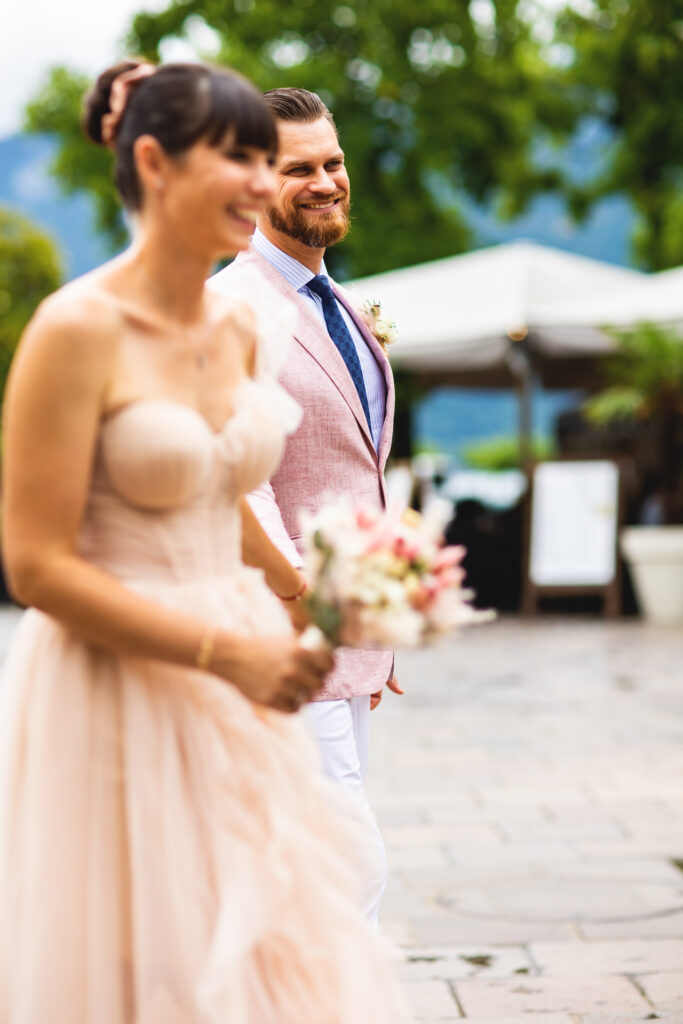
[621,526,683,626]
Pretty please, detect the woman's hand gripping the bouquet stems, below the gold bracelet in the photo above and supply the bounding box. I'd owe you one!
[210,636,334,712]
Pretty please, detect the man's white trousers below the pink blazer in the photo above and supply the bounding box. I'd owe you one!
[305,695,387,924]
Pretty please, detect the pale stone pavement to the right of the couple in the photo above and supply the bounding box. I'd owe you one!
[368,617,683,1024]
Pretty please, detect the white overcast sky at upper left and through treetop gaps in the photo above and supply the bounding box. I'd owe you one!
[0,0,577,137]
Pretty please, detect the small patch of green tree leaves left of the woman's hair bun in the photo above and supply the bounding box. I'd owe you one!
[26,68,127,248]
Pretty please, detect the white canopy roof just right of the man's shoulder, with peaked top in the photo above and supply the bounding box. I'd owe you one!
[348,242,645,383]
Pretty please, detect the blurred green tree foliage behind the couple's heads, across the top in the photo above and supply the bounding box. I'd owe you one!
[18,0,683,276]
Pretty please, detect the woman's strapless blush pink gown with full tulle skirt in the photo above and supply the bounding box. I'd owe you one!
[0,378,408,1024]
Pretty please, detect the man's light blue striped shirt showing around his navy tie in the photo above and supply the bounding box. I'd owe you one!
[252,228,386,449]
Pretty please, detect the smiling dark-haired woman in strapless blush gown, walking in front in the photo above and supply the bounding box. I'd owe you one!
[0,61,405,1024]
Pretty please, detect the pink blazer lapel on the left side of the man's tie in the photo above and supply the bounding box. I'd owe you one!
[236,250,376,452]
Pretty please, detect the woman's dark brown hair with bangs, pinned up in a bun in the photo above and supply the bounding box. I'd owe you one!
[83,60,278,210]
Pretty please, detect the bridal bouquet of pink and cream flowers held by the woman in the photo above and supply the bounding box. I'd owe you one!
[302,500,494,647]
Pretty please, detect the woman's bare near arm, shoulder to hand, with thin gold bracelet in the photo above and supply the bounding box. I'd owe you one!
[3,294,331,710]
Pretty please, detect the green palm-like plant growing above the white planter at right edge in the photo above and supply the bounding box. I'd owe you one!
[584,324,683,425]
